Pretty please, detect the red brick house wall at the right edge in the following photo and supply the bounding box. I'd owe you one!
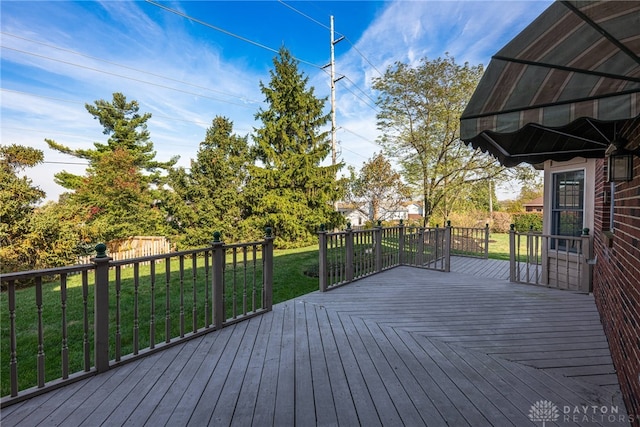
[593,125,640,425]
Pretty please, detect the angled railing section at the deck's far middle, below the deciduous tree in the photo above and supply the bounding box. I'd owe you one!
[318,223,451,292]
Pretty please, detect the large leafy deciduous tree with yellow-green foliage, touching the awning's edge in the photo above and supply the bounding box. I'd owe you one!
[373,56,504,223]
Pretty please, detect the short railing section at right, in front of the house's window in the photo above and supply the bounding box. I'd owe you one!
[509,225,592,292]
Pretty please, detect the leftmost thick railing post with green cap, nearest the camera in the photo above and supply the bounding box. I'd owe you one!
[91,243,111,372]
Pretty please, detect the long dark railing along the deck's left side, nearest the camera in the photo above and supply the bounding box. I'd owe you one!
[0,230,273,407]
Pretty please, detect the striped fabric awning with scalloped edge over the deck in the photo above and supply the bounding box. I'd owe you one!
[460,1,640,166]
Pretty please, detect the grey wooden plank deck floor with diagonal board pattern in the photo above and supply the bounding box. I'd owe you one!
[2,261,628,427]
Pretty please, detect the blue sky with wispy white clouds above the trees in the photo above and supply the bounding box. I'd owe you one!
[0,0,551,200]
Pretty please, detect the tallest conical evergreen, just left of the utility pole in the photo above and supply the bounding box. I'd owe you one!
[248,47,342,247]
